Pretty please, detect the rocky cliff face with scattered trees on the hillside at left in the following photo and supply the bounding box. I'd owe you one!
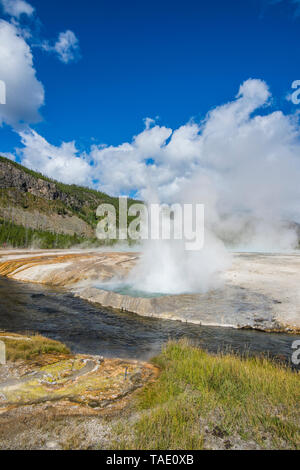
[0,158,99,238]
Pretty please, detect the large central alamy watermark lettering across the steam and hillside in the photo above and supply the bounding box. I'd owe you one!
[96,197,204,251]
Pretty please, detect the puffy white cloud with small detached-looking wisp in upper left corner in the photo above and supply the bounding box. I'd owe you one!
[0,0,80,129]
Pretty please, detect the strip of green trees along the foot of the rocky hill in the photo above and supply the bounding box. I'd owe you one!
[0,219,88,249]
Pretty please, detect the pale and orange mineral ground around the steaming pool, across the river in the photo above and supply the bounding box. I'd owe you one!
[0,250,300,333]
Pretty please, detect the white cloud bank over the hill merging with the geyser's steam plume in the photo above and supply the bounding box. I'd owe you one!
[10,79,300,292]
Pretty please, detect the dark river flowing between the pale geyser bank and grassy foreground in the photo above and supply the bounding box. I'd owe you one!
[0,277,300,368]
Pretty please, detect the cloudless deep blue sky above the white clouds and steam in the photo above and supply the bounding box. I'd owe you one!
[0,0,300,151]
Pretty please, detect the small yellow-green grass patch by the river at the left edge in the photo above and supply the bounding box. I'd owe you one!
[0,333,70,361]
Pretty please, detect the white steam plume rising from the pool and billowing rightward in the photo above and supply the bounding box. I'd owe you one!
[123,80,300,294]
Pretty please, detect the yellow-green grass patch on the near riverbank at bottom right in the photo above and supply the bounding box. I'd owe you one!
[115,342,300,450]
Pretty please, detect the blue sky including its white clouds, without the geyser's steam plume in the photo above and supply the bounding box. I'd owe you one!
[0,0,300,208]
